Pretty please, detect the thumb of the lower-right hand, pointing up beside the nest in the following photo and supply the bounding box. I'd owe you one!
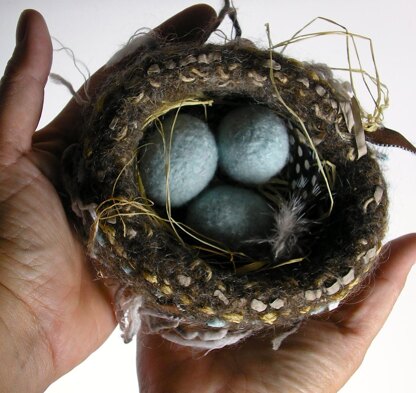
[330,234,416,343]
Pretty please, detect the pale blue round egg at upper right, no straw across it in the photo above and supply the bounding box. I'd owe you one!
[218,105,289,184]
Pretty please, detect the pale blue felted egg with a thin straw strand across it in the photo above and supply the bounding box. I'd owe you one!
[139,114,218,207]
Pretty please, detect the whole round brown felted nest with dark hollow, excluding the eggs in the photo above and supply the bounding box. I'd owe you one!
[64,6,388,348]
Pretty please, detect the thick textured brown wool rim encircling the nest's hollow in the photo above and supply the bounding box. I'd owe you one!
[64,35,387,339]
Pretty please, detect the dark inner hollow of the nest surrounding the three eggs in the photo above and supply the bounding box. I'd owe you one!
[136,99,330,274]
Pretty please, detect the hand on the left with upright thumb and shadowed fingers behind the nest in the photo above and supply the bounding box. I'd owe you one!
[0,5,215,393]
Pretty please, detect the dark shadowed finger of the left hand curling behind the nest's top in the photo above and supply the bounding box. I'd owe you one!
[35,4,217,152]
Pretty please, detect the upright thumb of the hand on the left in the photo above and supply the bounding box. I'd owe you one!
[0,10,52,163]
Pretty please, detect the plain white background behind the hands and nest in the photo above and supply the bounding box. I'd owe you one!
[0,0,416,393]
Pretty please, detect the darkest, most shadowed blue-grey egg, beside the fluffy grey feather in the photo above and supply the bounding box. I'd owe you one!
[186,185,273,248]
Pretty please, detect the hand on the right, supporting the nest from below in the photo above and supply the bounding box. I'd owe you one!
[137,234,416,393]
